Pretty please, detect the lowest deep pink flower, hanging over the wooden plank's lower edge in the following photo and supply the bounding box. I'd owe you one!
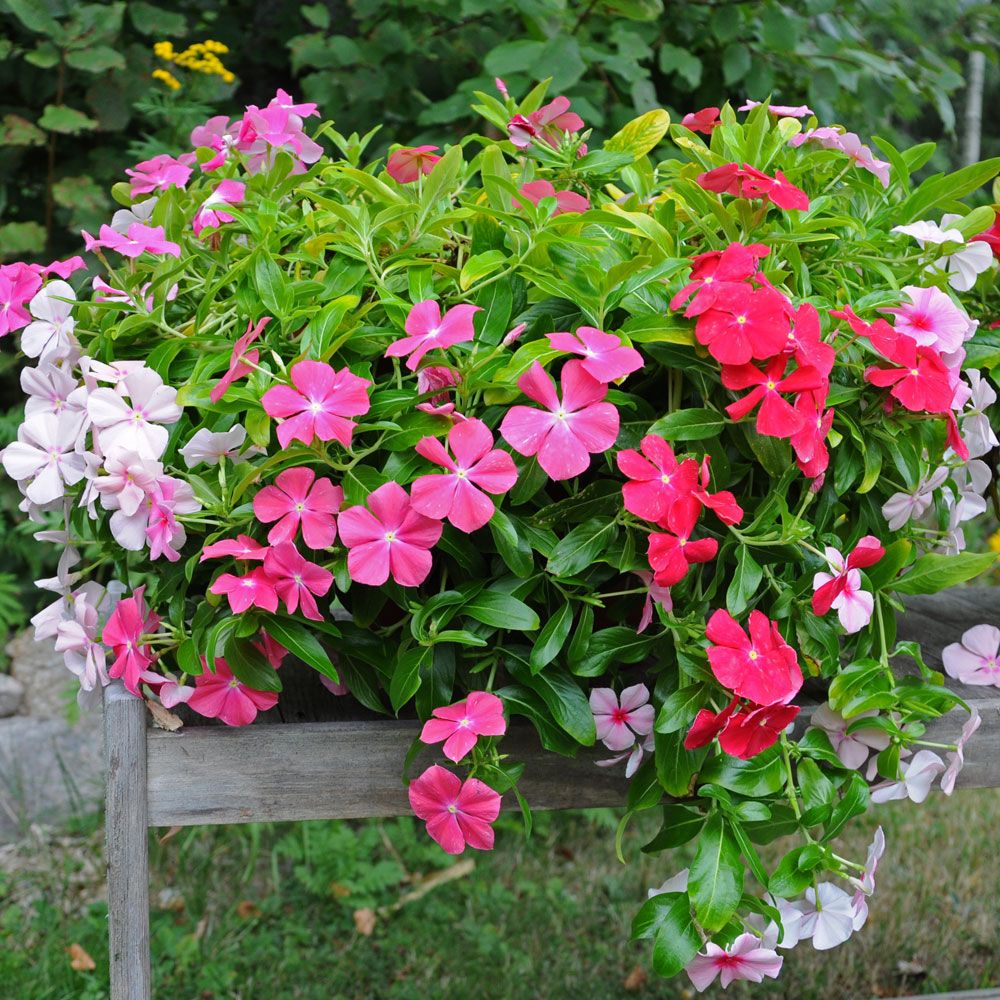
[409,764,500,854]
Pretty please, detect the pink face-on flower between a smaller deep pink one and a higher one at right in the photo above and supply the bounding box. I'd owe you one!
[338,482,442,587]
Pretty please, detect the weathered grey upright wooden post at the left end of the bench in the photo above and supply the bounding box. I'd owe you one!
[104,681,150,1000]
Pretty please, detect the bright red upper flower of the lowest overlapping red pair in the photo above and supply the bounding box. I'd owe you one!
[705,608,802,705]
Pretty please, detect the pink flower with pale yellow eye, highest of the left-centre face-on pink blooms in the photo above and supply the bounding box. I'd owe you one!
[261,361,371,448]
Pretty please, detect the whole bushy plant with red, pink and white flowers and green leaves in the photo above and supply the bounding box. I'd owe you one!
[0,81,1000,989]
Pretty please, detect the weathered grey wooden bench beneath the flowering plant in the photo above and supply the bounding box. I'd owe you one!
[104,588,1000,1000]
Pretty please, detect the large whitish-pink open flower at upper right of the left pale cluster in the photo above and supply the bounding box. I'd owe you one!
[87,368,182,460]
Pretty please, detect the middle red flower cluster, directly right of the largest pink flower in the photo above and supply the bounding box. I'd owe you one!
[618,434,743,587]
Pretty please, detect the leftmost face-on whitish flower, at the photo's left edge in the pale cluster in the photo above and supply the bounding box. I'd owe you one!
[0,411,85,505]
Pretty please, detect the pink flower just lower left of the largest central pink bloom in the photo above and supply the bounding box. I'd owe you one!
[410,419,517,533]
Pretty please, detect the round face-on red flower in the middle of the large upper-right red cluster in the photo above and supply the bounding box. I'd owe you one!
[694,284,791,365]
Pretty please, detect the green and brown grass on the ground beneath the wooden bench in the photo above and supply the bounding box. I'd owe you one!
[0,790,1000,1000]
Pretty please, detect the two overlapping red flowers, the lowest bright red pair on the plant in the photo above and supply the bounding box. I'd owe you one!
[684,609,802,760]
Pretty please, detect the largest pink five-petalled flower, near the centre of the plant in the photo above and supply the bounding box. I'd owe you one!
[500,361,618,479]
